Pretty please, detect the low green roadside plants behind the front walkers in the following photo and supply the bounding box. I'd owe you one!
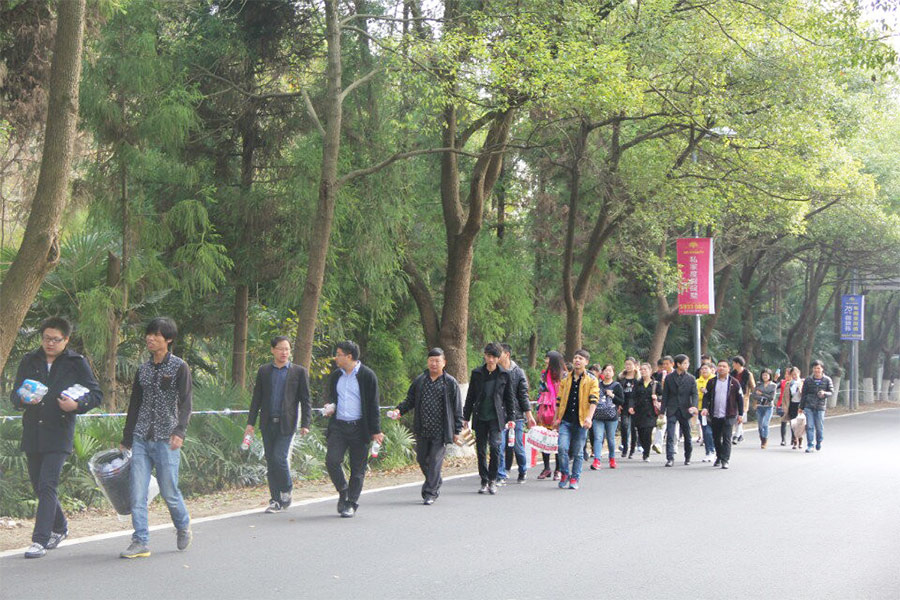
[0,403,415,518]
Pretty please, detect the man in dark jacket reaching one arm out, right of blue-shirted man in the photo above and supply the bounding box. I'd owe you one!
[389,348,462,505]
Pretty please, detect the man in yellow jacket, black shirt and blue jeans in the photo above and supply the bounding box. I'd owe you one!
[553,350,600,490]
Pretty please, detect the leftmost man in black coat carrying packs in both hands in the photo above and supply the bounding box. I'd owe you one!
[11,317,103,558]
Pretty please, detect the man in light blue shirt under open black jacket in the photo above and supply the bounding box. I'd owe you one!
[325,341,384,518]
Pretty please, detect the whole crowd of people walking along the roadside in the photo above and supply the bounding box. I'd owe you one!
[12,317,834,558]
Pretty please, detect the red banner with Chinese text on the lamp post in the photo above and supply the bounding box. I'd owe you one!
[677,238,716,315]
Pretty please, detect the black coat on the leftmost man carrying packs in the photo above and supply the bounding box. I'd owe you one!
[11,348,103,453]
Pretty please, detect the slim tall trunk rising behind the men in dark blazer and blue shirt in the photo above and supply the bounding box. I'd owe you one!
[294,0,343,368]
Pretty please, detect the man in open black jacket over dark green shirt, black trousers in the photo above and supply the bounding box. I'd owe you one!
[463,342,515,494]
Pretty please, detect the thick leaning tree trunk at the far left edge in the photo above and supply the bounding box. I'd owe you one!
[0,0,85,371]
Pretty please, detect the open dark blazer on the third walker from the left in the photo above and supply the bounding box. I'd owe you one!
[247,363,312,435]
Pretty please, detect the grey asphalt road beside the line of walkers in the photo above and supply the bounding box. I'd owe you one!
[0,410,900,600]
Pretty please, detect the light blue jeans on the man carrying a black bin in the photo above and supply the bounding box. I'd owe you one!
[131,436,191,544]
